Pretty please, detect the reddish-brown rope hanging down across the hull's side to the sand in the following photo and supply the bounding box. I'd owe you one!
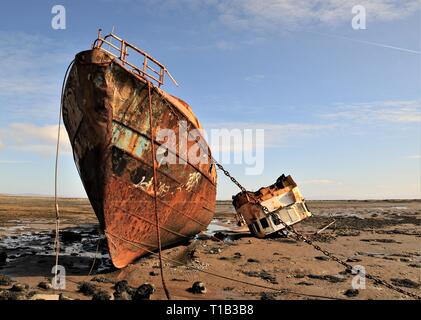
[148,81,171,300]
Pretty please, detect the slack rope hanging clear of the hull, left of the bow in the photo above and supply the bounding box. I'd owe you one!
[54,60,75,277]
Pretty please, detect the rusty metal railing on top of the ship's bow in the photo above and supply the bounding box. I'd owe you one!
[92,29,178,87]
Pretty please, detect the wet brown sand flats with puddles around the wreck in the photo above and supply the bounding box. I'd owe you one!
[0,196,421,299]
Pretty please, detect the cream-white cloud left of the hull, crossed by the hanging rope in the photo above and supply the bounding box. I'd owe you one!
[0,123,71,156]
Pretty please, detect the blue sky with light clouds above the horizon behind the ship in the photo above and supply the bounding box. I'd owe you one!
[0,0,421,199]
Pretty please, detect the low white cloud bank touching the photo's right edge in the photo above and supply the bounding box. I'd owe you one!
[322,100,421,124]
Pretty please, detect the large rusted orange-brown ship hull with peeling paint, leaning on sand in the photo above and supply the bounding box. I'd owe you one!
[63,49,216,268]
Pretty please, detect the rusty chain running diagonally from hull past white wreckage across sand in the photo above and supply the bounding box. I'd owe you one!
[156,88,421,300]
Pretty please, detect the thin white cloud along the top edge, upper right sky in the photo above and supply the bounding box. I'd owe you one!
[213,0,420,31]
